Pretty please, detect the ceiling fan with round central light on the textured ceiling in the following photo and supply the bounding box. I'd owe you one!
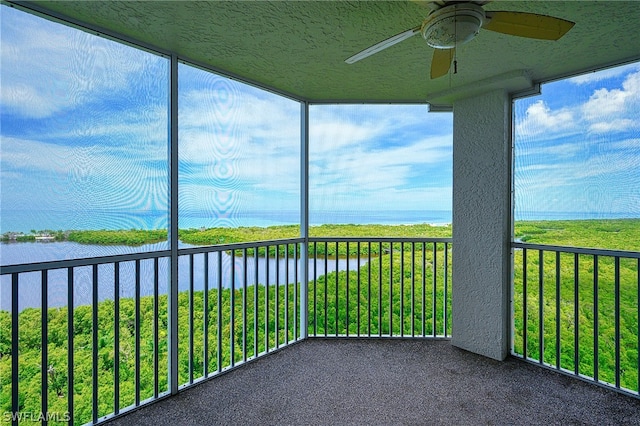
[345,0,575,79]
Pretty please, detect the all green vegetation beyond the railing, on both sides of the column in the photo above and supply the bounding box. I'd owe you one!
[0,220,640,423]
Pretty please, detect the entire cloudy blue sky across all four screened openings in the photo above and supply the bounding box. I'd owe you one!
[0,6,640,232]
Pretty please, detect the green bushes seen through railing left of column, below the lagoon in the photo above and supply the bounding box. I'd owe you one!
[0,247,451,424]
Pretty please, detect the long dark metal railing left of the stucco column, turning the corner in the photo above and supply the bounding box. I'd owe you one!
[0,238,451,424]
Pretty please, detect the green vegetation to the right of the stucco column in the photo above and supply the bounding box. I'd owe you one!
[514,219,640,391]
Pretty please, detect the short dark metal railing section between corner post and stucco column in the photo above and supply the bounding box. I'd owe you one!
[308,238,452,337]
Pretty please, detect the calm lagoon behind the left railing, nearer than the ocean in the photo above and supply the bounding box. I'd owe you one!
[0,242,366,311]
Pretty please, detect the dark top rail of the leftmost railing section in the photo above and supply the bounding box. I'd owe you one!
[0,250,171,275]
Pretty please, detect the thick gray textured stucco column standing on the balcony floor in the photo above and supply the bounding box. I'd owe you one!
[451,90,511,360]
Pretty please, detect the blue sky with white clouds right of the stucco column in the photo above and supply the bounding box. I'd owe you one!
[514,63,640,217]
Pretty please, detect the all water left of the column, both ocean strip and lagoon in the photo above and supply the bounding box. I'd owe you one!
[0,209,451,310]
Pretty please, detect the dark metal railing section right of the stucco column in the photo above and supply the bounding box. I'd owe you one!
[512,242,640,397]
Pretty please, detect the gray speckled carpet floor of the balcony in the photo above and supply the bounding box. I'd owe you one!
[109,339,640,425]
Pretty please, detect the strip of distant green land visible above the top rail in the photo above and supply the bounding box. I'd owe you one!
[0,218,640,249]
